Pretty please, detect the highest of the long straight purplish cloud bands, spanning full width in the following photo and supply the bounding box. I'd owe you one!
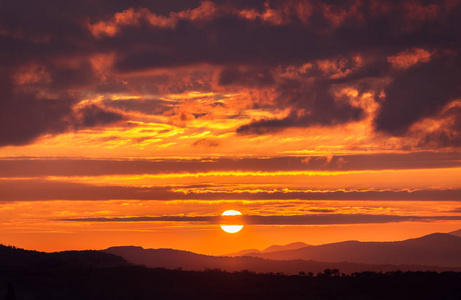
[0,154,461,177]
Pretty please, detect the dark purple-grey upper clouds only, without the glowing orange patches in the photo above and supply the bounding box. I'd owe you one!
[0,0,461,146]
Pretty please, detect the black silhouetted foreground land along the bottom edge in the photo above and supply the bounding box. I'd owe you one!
[0,266,461,300]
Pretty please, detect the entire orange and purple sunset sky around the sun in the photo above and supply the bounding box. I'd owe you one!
[0,0,461,255]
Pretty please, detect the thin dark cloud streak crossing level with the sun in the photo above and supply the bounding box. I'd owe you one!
[59,214,461,225]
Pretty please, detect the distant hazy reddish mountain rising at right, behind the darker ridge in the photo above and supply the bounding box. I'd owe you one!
[243,233,461,267]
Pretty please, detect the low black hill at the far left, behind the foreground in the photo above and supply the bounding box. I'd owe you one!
[0,244,130,269]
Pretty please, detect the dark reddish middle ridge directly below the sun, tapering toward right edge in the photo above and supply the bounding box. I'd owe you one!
[103,246,461,274]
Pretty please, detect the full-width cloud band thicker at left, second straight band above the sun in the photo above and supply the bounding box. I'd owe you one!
[0,180,461,201]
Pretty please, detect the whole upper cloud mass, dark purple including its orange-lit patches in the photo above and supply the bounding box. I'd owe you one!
[0,0,461,148]
